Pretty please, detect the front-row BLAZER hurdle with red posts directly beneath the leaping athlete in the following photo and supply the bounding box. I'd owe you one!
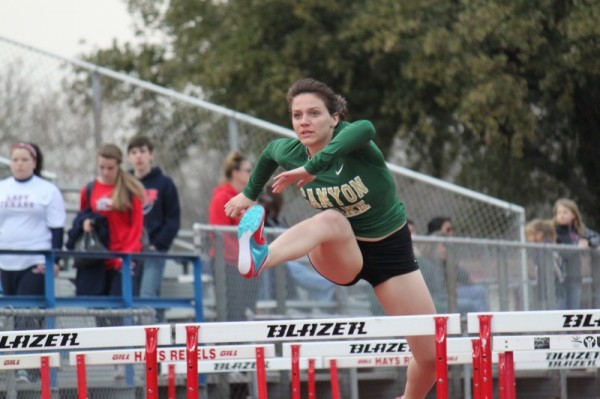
[175,314,461,399]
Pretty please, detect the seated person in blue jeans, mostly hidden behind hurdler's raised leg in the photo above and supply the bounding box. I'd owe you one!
[258,188,335,302]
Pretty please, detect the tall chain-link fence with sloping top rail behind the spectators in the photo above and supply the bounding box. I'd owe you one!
[0,37,525,240]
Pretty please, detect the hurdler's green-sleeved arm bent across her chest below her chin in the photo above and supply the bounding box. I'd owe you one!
[304,120,375,175]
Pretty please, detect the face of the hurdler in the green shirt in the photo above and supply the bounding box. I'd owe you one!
[291,93,339,155]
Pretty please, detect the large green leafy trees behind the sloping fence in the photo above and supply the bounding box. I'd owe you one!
[77,0,600,230]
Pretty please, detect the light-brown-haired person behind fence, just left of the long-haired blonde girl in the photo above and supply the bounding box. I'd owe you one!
[525,219,565,310]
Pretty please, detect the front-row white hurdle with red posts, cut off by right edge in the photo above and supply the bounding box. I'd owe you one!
[467,309,600,399]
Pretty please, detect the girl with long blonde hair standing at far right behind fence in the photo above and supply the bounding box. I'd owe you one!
[554,198,598,309]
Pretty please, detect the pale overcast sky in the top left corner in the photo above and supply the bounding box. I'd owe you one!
[0,0,133,57]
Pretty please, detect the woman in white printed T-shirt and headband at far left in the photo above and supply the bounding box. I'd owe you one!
[0,142,66,381]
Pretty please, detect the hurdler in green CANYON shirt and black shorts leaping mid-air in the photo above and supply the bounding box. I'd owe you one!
[225,79,435,399]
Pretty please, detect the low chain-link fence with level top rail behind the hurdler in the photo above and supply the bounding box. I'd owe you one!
[195,224,600,321]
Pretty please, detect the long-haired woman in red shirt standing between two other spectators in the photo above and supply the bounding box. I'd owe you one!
[76,144,144,308]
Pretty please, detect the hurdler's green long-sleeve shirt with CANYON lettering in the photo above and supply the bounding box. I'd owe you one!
[244,120,406,238]
